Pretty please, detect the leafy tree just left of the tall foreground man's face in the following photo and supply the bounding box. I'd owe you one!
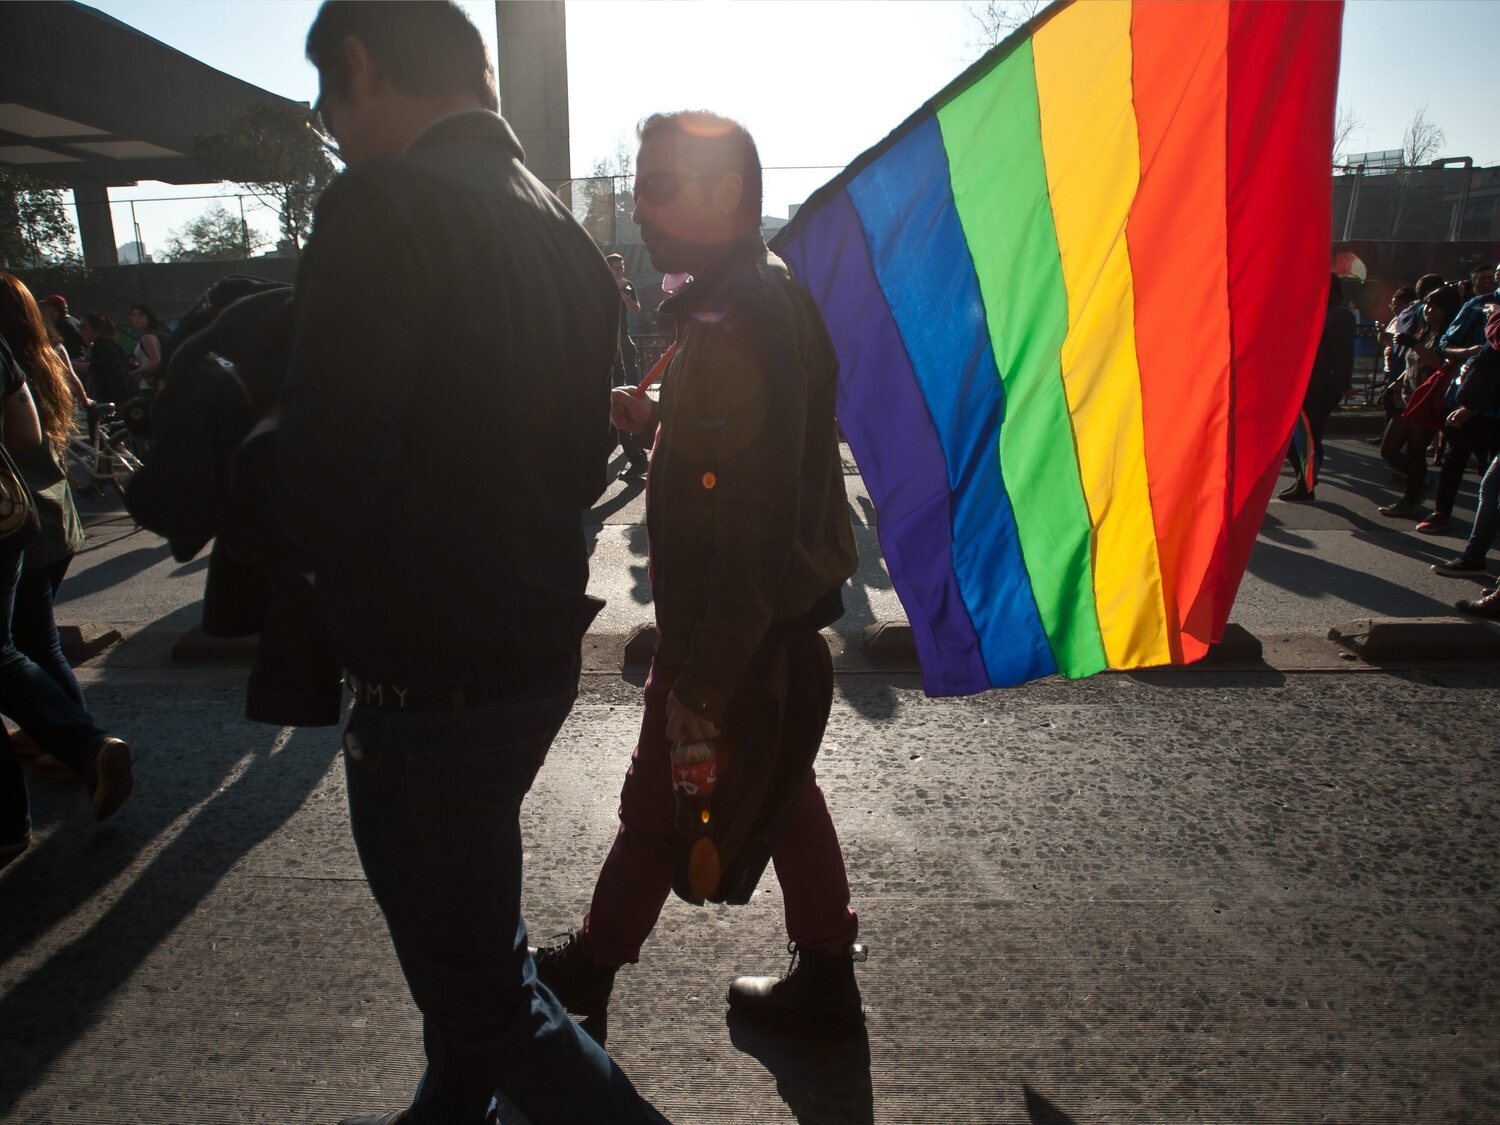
[192,102,339,255]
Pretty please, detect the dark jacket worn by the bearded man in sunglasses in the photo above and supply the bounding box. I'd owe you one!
[647,234,858,722]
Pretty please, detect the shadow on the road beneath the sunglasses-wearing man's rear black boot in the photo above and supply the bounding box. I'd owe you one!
[725,1013,875,1125]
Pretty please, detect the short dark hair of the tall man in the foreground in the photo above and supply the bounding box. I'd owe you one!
[308,0,500,113]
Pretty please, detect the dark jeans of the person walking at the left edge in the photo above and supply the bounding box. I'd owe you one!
[0,551,104,843]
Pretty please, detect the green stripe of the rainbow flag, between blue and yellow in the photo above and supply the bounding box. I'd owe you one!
[938,41,1107,677]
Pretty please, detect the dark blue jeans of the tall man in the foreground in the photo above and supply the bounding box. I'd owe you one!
[344,695,666,1125]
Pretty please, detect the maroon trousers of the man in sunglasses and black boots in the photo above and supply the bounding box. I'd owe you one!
[579,632,860,966]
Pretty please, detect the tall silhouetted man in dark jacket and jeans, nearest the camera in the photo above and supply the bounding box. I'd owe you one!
[279,0,675,1125]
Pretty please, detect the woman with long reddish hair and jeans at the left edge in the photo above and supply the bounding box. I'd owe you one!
[0,273,134,846]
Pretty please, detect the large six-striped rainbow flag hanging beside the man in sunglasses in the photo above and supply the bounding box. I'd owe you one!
[773,0,1343,695]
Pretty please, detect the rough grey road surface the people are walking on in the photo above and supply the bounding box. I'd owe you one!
[0,441,1500,1125]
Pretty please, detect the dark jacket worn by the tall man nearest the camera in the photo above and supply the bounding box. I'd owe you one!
[278,111,620,695]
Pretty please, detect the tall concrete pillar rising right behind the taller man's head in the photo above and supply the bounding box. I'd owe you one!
[495,0,572,188]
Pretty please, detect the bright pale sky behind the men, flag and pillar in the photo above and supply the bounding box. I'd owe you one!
[79,0,1500,254]
